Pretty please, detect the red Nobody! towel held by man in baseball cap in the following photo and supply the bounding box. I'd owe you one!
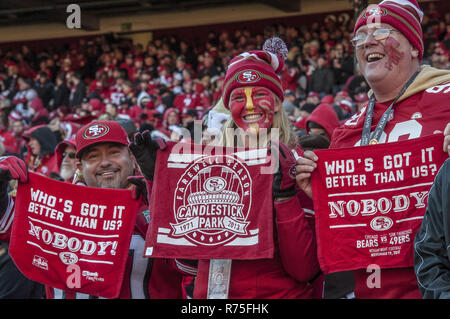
[9,172,139,298]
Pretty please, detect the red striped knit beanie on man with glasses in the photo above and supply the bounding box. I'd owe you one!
[353,0,423,60]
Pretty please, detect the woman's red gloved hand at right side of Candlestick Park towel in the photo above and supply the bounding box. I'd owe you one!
[271,140,297,199]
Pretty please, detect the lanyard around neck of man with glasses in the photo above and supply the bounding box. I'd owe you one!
[361,68,421,145]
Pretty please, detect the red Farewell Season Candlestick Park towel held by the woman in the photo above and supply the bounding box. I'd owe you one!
[145,143,274,259]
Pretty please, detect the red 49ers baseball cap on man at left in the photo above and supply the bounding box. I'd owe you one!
[75,121,129,158]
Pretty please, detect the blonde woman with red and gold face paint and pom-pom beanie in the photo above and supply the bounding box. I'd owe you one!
[194,38,322,299]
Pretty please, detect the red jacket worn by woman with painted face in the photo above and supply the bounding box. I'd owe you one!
[194,196,320,299]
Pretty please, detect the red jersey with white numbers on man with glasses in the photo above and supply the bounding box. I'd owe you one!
[330,77,450,299]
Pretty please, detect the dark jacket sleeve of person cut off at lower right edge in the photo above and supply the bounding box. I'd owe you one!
[414,159,450,299]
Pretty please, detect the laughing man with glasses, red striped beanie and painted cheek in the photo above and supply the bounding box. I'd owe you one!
[297,0,450,299]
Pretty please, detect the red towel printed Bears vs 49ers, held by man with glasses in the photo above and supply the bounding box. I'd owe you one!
[311,134,448,274]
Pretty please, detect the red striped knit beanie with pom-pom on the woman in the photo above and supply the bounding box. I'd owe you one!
[222,37,288,109]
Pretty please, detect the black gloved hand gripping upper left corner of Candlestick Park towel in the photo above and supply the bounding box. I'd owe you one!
[128,130,167,181]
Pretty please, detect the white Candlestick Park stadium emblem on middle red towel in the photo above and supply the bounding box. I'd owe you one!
[171,156,252,245]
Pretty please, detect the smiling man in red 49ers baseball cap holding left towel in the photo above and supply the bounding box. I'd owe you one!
[0,121,189,299]
